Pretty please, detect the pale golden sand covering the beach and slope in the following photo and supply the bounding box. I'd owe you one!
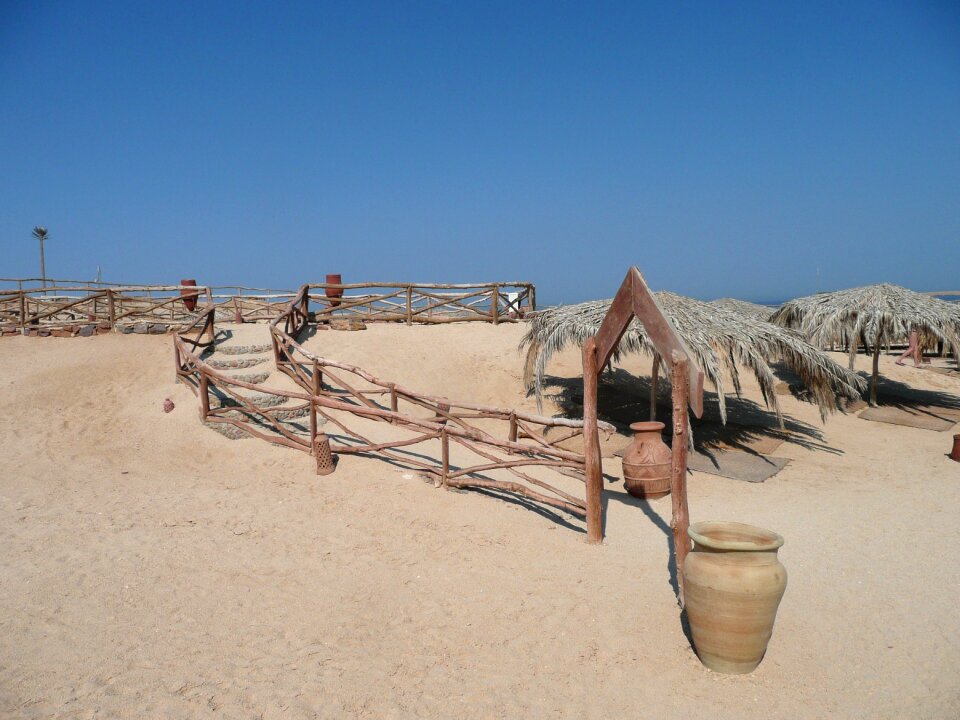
[0,323,960,720]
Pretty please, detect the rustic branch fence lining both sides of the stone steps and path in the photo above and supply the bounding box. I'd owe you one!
[174,285,614,528]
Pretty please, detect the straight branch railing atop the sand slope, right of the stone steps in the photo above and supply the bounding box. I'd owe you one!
[306,282,537,325]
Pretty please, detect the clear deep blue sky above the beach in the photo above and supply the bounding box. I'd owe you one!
[0,0,960,302]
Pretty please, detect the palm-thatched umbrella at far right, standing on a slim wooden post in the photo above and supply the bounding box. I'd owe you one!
[771,284,960,405]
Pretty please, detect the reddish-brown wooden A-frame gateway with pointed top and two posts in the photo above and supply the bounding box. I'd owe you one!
[583,266,703,604]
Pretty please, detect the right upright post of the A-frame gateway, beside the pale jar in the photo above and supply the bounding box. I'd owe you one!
[670,350,690,607]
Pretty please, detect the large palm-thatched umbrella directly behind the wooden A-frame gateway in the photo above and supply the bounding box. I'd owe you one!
[520,292,865,423]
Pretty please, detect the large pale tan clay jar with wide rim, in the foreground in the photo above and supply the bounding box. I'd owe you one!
[683,522,787,674]
